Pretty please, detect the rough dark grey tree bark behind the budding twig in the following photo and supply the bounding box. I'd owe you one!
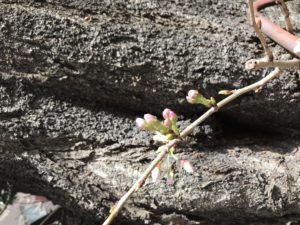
[0,0,300,224]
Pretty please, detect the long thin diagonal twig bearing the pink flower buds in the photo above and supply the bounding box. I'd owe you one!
[102,68,280,225]
